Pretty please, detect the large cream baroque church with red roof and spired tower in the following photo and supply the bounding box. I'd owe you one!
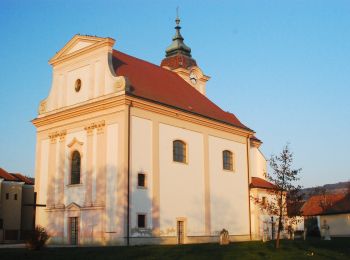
[32,18,270,245]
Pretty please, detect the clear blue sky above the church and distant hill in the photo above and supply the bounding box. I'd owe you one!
[0,0,350,187]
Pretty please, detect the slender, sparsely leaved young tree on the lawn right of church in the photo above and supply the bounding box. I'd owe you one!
[253,144,302,248]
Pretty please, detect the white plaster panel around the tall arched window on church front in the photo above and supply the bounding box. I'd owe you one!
[64,130,87,206]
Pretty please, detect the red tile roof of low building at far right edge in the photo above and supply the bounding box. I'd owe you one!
[301,193,350,216]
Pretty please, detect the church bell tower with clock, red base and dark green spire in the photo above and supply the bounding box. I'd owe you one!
[160,16,210,95]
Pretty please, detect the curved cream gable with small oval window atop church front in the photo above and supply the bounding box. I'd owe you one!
[39,34,128,116]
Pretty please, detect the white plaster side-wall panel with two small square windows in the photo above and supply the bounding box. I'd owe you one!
[130,116,152,235]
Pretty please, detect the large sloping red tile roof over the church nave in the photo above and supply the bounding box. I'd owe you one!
[113,50,252,131]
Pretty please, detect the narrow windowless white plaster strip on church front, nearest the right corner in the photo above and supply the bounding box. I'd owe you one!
[106,123,119,232]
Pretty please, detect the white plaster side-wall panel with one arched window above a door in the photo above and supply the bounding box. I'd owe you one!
[159,124,205,236]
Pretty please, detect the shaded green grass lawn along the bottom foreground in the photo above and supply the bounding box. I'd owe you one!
[0,238,350,260]
